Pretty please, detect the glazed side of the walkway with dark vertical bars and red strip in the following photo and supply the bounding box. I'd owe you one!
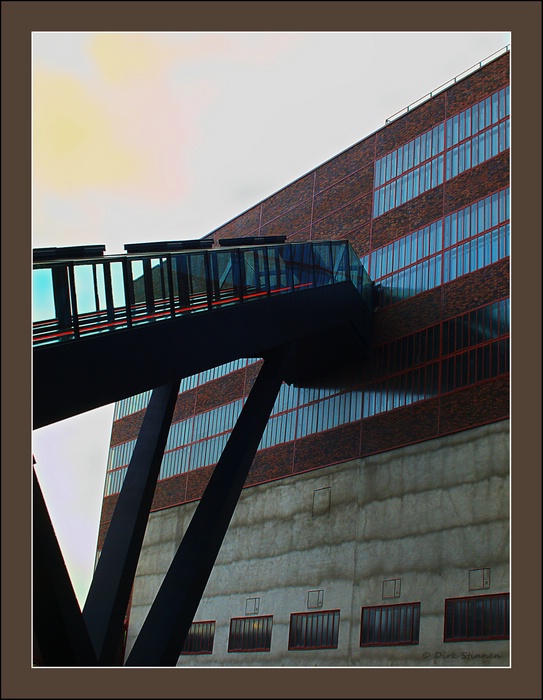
[33,241,373,346]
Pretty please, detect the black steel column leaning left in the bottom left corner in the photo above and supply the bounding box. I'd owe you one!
[32,472,96,666]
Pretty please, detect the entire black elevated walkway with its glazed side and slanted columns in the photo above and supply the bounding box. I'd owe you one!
[34,242,373,666]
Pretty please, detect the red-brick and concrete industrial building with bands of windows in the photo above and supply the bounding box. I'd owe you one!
[98,52,510,665]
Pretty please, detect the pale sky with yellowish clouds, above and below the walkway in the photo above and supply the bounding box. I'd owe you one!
[32,32,514,606]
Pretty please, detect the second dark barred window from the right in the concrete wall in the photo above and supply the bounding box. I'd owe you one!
[360,603,420,647]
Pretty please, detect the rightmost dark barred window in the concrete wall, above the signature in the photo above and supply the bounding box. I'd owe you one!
[443,593,509,642]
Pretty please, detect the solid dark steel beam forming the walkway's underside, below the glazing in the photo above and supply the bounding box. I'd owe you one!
[33,282,371,430]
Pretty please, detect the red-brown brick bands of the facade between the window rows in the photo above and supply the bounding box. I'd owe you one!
[100,54,509,546]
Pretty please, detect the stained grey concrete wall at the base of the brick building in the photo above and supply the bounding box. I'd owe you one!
[127,421,509,667]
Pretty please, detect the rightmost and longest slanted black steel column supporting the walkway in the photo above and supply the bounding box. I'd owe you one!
[125,344,294,666]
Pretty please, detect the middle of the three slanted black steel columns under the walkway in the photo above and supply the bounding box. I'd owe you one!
[83,381,179,666]
